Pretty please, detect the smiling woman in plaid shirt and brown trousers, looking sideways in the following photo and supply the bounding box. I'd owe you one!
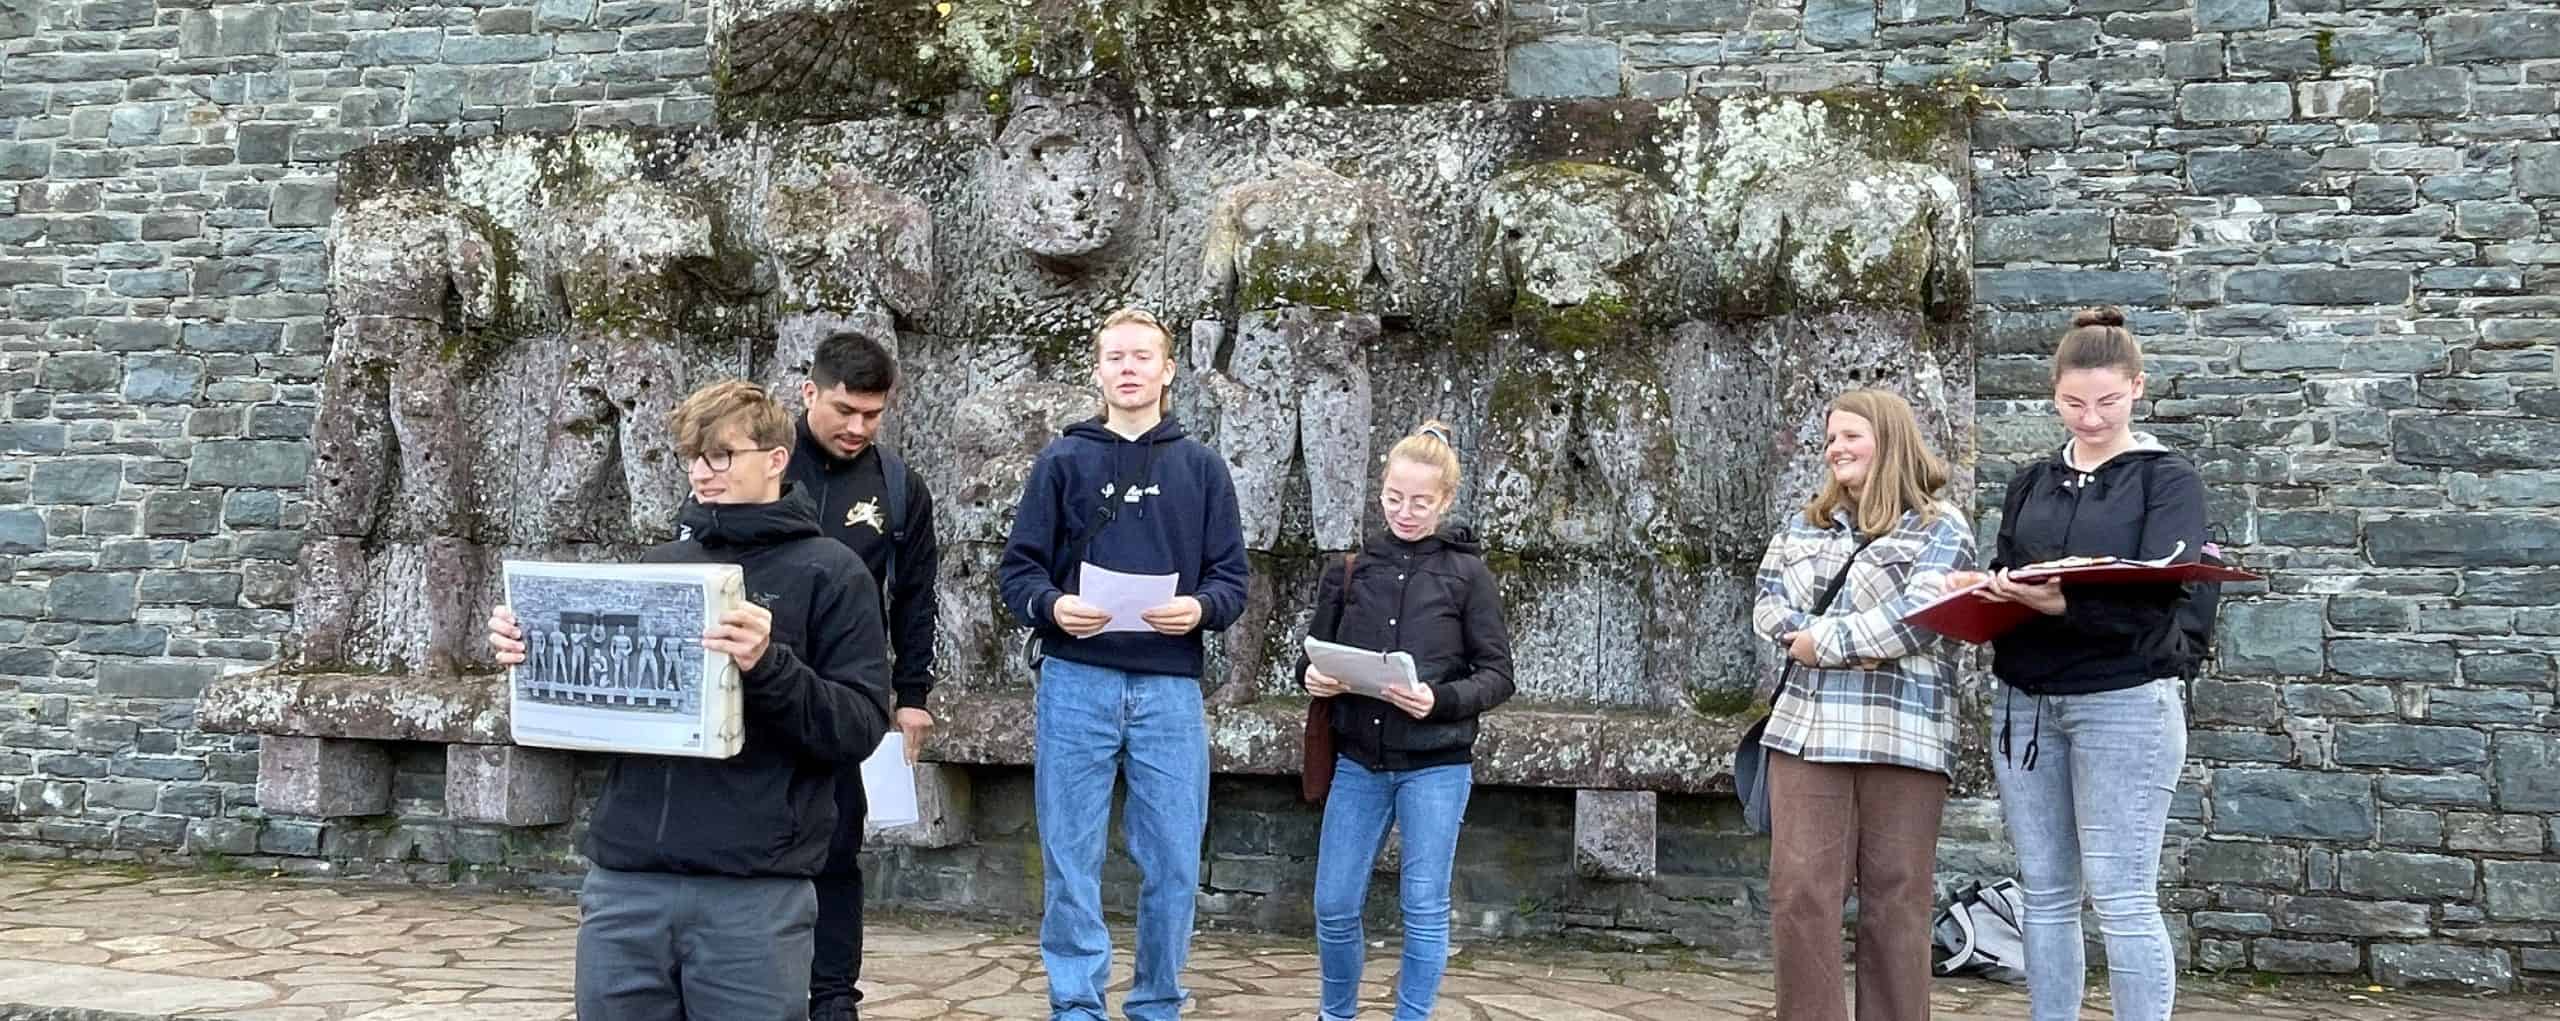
[1751,389,1974,1021]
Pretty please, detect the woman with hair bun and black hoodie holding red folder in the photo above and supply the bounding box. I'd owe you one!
[1951,310,2204,1021]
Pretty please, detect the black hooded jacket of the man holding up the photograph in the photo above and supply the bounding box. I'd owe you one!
[586,486,888,875]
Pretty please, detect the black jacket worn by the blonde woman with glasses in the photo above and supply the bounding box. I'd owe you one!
[1298,530,1513,770]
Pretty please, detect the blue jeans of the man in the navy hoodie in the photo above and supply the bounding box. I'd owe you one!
[1032,655,1208,1021]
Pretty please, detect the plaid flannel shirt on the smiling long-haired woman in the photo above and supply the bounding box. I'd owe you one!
[1751,504,1974,773]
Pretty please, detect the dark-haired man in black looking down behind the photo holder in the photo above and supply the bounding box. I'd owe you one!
[788,333,942,1021]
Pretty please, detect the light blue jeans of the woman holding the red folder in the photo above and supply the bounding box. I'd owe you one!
[1992,678,2186,1021]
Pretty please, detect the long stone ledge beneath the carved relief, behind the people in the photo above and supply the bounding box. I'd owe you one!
[197,670,1748,793]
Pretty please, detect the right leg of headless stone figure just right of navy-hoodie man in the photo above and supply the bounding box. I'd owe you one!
[1298,312,1377,550]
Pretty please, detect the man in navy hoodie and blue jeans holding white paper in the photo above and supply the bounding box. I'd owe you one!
[1001,310,1244,1021]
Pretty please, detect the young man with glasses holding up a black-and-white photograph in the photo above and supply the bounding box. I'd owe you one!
[489,381,888,1021]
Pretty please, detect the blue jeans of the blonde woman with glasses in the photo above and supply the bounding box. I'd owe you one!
[1316,757,1475,1021]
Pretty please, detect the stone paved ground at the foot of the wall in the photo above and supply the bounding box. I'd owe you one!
[0,862,2560,1021]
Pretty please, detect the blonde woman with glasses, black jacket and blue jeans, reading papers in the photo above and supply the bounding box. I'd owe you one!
[1300,422,1513,1021]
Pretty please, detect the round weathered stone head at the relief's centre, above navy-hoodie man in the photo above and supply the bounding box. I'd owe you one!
[988,82,1149,264]
